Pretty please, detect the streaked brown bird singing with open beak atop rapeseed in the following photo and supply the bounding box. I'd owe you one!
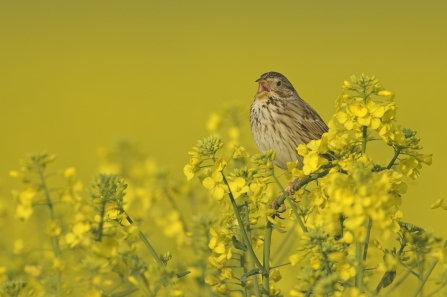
[250,72,328,169]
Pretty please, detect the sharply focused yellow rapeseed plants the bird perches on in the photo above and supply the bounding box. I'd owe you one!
[184,75,443,296]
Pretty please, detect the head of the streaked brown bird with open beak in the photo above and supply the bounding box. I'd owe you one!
[256,71,296,100]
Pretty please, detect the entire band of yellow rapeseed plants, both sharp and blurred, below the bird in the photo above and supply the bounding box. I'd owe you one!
[0,75,447,297]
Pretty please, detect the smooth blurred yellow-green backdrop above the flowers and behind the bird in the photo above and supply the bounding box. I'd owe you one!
[0,0,447,236]
